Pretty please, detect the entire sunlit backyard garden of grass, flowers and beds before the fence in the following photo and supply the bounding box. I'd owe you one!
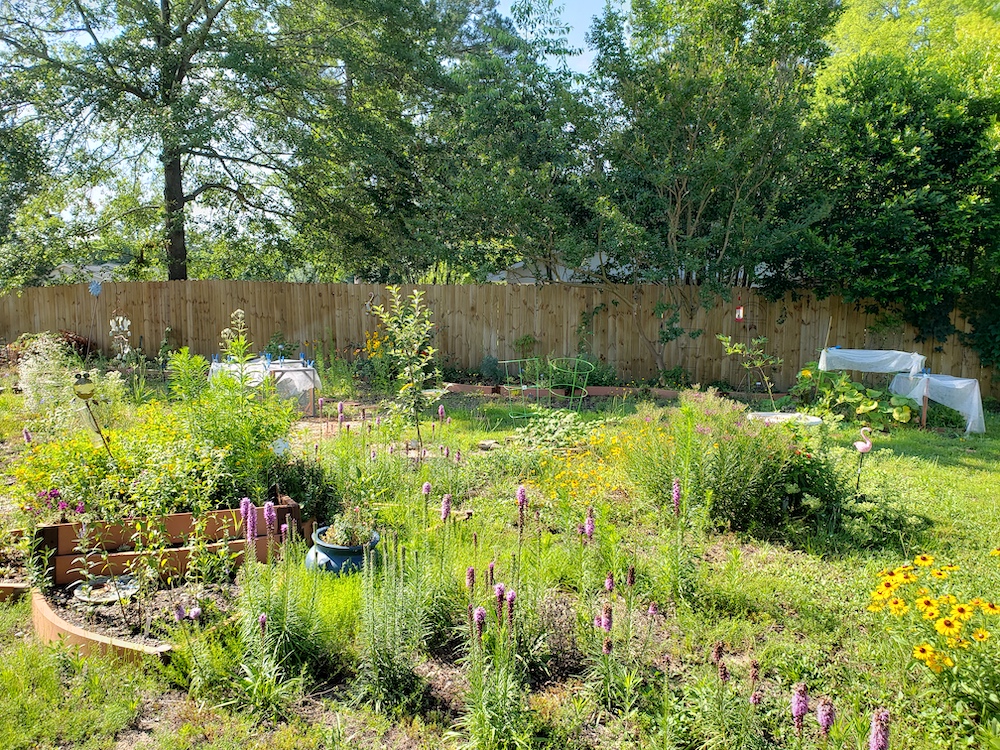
[0,293,1000,750]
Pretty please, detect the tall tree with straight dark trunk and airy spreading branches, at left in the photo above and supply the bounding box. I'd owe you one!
[0,0,442,279]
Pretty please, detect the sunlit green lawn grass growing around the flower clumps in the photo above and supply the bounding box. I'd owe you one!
[0,390,1000,750]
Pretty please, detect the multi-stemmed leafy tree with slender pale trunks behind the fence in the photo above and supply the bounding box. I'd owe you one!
[590,0,837,369]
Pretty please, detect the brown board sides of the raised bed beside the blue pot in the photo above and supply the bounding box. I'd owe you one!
[35,498,299,585]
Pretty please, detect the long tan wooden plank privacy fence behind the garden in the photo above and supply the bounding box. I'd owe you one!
[0,281,1000,396]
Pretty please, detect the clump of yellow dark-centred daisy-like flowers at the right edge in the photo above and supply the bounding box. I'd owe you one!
[868,548,1000,723]
